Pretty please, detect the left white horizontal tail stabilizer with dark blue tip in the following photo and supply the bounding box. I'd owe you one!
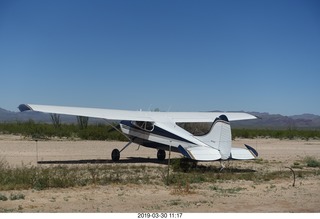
[178,145,221,161]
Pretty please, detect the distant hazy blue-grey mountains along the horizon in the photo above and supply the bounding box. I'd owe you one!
[0,108,320,129]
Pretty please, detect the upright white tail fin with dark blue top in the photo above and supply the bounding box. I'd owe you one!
[197,115,232,160]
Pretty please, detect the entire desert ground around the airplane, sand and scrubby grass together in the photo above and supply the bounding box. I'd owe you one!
[0,139,320,212]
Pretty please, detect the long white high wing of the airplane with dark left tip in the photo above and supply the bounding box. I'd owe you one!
[18,104,257,123]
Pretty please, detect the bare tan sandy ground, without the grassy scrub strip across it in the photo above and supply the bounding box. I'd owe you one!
[0,135,320,213]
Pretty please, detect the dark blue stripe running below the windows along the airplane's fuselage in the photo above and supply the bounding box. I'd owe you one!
[120,121,194,144]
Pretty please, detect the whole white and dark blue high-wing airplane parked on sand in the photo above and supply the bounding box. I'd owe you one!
[18,104,258,161]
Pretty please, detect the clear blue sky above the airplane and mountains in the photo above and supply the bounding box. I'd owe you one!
[0,0,320,115]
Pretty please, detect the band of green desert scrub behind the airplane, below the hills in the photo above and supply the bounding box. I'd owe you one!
[0,120,320,141]
